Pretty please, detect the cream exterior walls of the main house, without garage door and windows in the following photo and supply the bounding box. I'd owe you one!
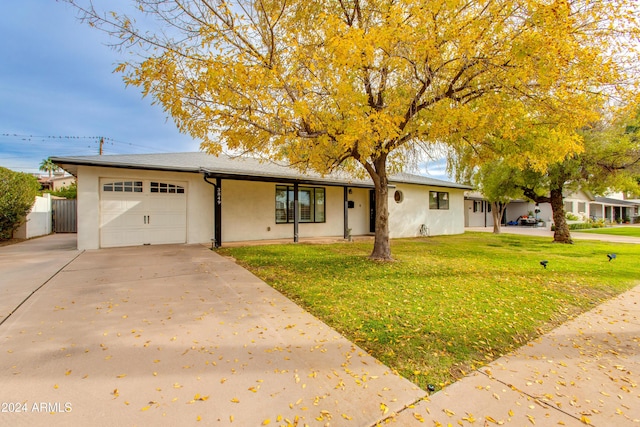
[77,166,464,250]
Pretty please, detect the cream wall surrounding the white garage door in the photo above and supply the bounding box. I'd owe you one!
[78,166,214,250]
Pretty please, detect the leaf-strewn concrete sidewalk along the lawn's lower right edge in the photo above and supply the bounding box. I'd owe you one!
[396,287,640,427]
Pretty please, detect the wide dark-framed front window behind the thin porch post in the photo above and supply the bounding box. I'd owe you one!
[276,185,326,224]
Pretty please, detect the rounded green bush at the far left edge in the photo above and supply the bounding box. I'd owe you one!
[0,167,40,240]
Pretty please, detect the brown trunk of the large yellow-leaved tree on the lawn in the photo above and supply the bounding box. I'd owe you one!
[367,155,392,261]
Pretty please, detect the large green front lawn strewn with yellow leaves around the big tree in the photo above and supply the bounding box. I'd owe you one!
[219,233,640,388]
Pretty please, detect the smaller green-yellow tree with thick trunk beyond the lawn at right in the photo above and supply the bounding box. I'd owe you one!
[464,110,640,243]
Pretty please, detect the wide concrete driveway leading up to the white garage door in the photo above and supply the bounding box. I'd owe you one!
[0,236,426,426]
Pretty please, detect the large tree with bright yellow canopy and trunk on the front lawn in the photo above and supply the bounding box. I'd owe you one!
[67,0,637,259]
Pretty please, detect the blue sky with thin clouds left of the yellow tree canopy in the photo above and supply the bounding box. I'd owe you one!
[0,0,446,179]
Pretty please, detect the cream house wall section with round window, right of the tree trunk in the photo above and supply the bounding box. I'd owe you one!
[389,184,464,238]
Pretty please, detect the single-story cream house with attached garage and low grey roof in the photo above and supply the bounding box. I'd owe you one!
[51,153,471,249]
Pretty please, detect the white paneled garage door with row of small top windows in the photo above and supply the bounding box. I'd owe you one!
[100,179,187,248]
